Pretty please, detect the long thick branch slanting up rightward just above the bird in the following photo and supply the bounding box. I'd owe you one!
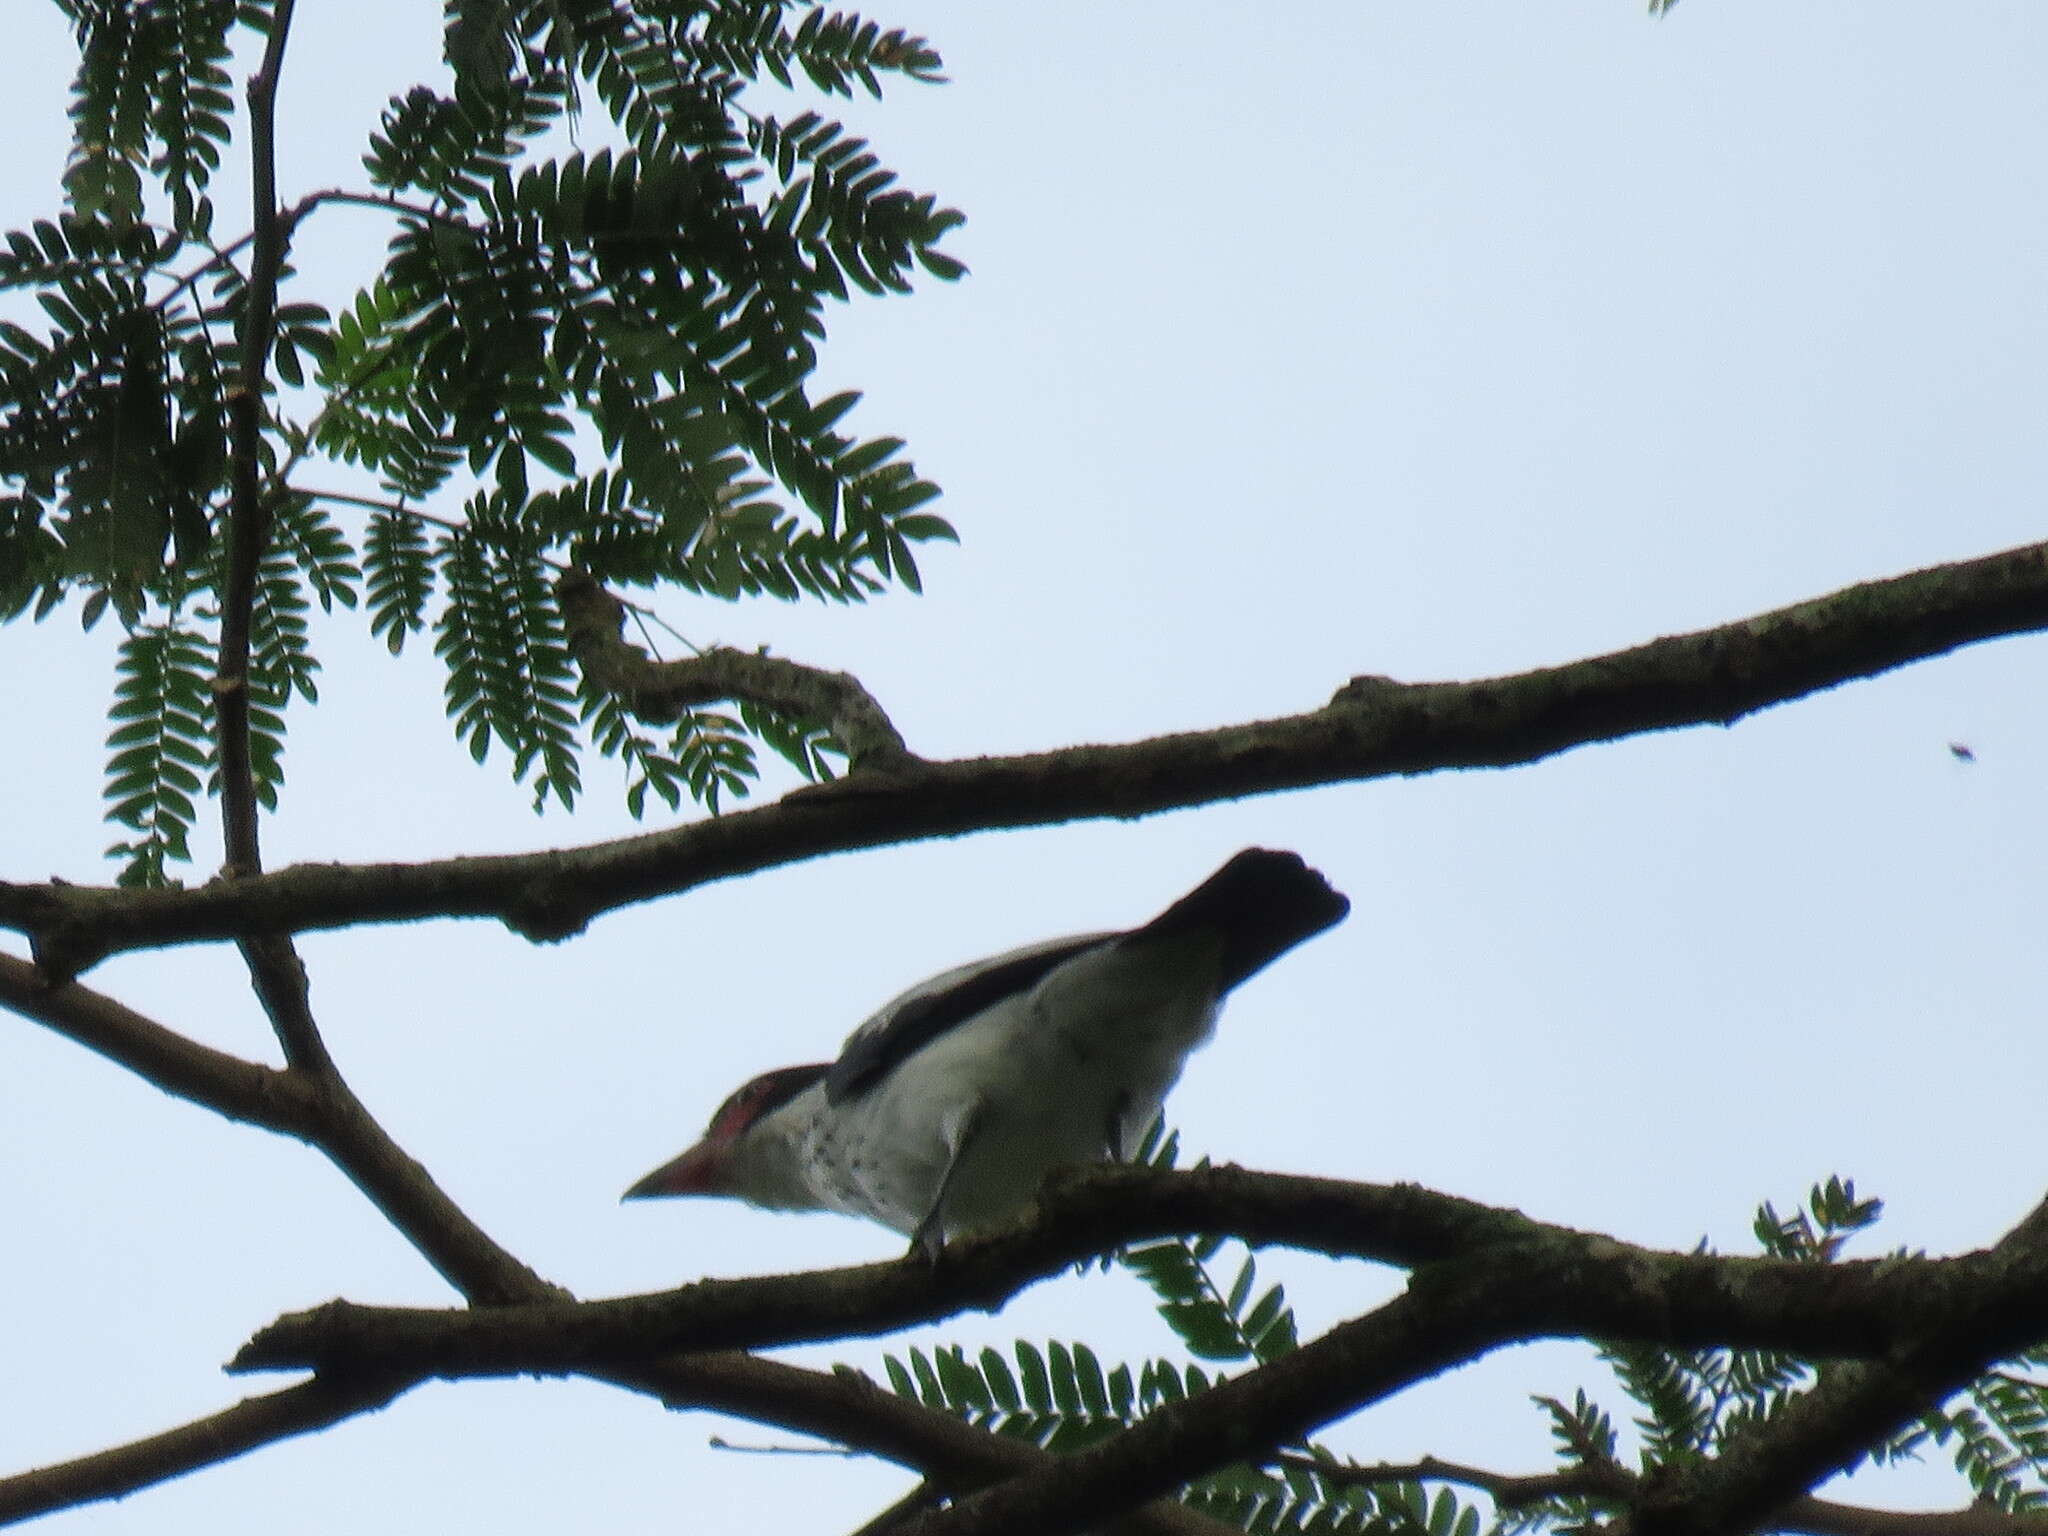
[0,545,2048,975]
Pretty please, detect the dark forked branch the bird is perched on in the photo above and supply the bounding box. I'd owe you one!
[220,1169,2048,1536]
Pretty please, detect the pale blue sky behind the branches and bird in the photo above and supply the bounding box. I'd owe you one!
[0,0,2048,1536]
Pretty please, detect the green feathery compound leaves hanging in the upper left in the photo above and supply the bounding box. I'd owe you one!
[0,0,965,881]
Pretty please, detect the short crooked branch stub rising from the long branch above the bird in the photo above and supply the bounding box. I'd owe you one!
[555,571,920,774]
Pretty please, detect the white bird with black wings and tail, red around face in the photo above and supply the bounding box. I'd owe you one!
[625,848,1352,1253]
